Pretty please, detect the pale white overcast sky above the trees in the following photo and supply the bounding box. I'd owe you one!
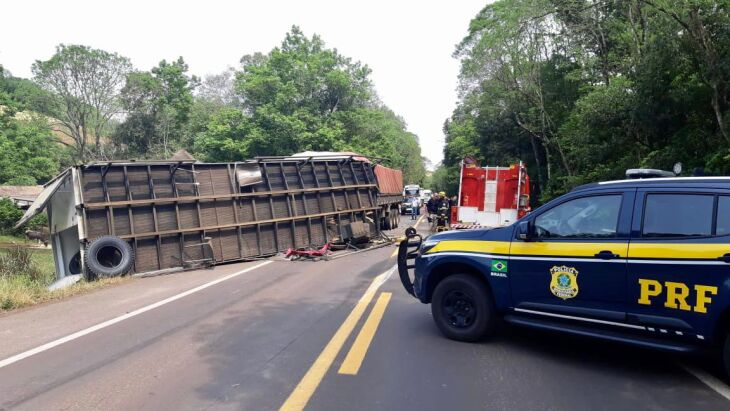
[0,0,487,167]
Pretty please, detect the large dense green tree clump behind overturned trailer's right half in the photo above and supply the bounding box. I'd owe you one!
[195,27,425,183]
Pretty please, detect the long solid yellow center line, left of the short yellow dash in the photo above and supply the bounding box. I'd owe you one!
[279,267,395,411]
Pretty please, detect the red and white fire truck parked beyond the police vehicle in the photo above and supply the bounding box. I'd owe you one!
[451,157,530,229]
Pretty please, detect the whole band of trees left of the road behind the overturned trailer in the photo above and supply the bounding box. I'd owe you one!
[0,26,425,185]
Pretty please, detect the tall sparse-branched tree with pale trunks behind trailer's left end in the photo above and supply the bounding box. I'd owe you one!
[32,44,132,161]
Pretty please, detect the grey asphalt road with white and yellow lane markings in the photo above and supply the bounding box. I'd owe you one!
[0,220,730,411]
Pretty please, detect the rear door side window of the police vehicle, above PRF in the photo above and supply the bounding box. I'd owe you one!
[642,194,715,237]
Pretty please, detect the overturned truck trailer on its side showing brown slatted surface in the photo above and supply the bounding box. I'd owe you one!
[18,155,402,279]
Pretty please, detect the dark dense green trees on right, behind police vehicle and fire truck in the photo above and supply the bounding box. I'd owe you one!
[434,0,730,200]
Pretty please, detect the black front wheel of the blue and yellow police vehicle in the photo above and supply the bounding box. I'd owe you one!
[431,274,497,342]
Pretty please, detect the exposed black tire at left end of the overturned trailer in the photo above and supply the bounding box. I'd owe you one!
[84,235,134,277]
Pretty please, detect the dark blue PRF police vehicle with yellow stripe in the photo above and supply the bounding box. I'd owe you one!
[398,177,730,373]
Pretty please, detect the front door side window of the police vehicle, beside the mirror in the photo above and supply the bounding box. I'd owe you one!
[535,194,622,238]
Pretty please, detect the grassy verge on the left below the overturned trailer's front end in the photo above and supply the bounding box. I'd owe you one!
[0,247,129,312]
